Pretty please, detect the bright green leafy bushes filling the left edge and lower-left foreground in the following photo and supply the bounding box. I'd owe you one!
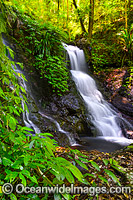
[0,11,77,200]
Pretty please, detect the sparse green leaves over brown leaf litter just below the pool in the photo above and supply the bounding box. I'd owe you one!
[68,149,121,187]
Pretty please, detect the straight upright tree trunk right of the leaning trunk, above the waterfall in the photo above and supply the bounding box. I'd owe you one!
[88,0,94,40]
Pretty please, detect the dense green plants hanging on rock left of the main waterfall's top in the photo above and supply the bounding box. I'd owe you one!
[9,9,68,95]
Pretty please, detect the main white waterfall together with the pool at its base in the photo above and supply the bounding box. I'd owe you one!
[63,44,133,152]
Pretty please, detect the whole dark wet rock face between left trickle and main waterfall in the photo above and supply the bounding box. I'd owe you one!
[3,35,92,146]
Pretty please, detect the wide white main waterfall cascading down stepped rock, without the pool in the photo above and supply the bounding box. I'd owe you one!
[63,44,127,137]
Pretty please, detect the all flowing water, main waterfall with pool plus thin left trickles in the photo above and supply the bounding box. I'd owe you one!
[3,36,133,152]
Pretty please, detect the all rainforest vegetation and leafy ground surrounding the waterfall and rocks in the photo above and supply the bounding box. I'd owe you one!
[0,0,133,200]
